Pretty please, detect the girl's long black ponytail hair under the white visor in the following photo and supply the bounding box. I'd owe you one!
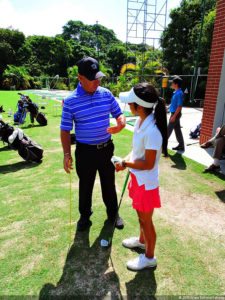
[134,82,168,156]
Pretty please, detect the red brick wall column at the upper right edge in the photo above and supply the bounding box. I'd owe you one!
[200,0,225,143]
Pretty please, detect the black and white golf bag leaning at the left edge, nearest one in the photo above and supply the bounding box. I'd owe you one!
[0,121,43,162]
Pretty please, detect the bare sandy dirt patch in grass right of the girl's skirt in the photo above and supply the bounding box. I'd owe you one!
[157,187,225,238]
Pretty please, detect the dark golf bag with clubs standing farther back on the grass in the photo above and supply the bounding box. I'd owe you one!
[14,93,48,126]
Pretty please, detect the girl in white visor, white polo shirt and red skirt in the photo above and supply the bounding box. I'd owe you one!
[115,83,167,271]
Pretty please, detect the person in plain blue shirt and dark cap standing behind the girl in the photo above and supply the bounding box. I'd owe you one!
[168,76,185,151]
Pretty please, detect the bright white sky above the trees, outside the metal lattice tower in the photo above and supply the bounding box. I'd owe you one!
[0,0,180,41]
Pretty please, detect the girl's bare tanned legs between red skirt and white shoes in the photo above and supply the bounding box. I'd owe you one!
[137,209,156,258]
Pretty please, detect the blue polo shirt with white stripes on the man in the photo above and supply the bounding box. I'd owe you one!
[60,83,122,145]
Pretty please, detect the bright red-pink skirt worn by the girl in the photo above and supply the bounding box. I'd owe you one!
[128,173,161,212]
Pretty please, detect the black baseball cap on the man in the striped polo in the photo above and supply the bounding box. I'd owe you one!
[77,57,105,81]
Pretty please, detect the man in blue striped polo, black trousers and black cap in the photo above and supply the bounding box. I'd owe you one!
[60,57,126,231]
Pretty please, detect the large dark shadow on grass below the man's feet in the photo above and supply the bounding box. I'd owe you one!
[39,224,122,299]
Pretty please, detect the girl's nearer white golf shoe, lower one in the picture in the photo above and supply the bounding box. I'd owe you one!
[127,254,157,271]
